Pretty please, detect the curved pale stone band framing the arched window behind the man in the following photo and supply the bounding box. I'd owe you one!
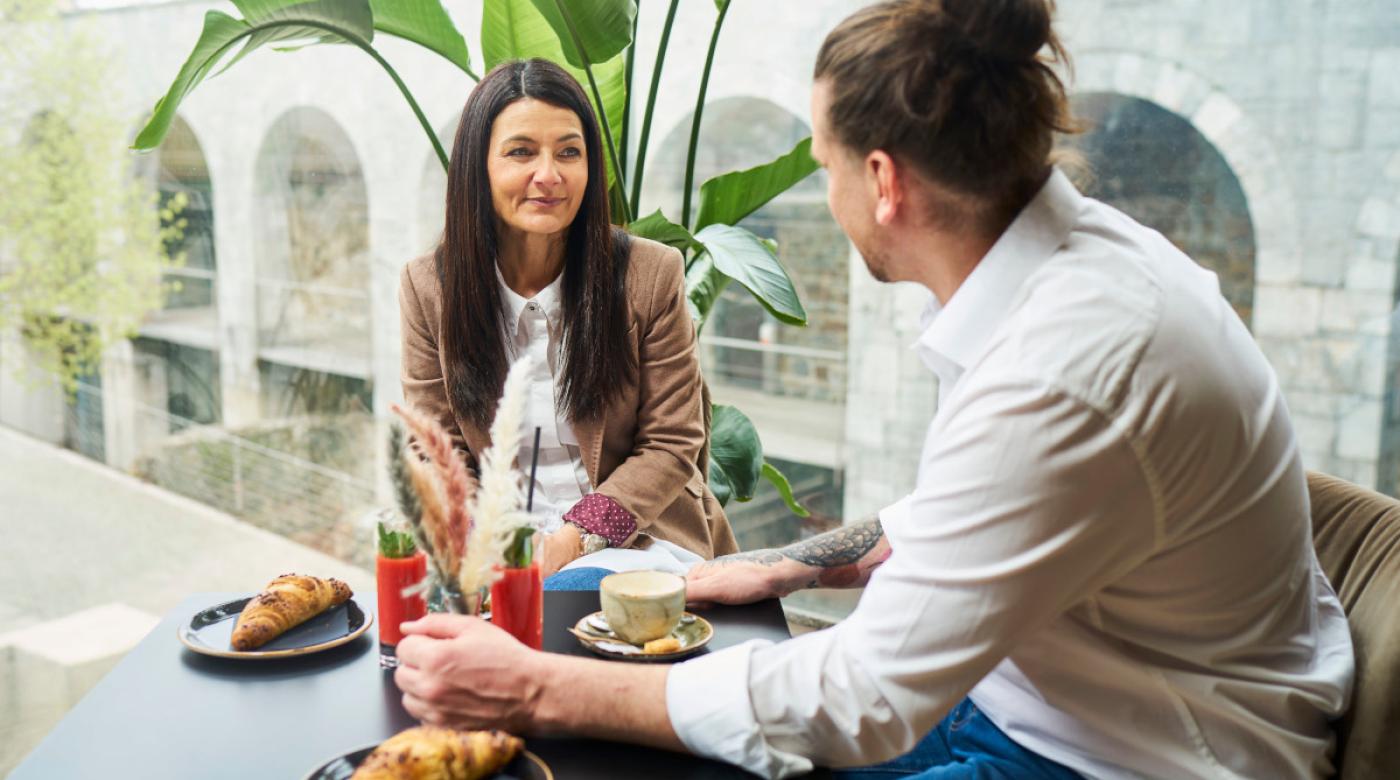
[1074,50,1302,319]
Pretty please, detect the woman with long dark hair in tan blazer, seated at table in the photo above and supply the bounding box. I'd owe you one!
[399,59,738,576]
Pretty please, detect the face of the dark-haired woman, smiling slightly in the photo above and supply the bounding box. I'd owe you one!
[486,98,588,235]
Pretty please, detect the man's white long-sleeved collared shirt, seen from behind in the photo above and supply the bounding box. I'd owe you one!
[666,172,1352,779]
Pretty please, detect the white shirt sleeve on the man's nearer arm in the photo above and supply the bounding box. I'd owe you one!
[666,378,1161,777]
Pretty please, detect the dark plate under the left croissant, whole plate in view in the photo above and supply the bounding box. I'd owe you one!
[179,597,374,660]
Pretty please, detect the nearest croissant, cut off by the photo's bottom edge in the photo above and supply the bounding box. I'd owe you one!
[350,725,525,780]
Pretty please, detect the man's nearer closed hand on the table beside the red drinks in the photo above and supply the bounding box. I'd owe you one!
[393,613,540,734]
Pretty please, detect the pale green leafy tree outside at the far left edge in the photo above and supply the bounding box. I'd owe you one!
[0,0,183,391]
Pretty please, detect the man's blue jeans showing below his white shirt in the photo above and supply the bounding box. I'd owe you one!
[834,699,1079,780]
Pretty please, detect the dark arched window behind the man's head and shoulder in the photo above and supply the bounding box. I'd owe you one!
[1067,92,1254,325]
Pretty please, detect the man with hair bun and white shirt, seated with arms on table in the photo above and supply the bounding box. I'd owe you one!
[398,0,1352,779]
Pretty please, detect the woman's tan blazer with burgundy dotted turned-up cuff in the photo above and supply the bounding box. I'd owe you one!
[399,238,739,559]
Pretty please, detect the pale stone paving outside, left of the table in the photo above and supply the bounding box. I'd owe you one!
[0,427,374,776]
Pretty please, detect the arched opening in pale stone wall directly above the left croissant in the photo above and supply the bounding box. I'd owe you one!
[252,106,370,377]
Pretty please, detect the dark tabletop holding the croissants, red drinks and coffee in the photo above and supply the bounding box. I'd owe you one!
[10,592,817,780]
